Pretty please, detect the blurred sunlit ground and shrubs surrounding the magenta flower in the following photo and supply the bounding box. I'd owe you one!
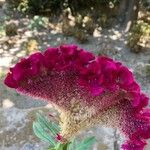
[0,0,150,150]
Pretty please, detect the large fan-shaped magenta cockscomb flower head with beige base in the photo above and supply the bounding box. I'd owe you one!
[4,45,150,150]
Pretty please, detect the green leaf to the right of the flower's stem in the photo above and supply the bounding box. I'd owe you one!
[75,137,95,150]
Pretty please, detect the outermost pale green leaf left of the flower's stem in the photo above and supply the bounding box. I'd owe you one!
[33,122,56,146]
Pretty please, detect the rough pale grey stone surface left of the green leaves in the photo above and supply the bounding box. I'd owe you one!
[0,107,48,150]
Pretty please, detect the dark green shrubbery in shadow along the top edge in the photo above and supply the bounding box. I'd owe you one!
[7,0,119,15]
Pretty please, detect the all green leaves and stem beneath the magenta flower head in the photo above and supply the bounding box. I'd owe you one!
[33,113,95,150]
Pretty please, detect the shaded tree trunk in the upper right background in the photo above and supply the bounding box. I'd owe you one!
[118,0,140,32]
